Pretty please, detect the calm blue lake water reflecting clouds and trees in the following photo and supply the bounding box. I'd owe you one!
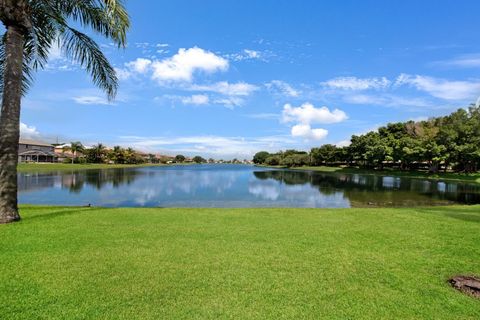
[19,165,480,208]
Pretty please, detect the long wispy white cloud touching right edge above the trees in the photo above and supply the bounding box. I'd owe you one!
[395,74,480,100]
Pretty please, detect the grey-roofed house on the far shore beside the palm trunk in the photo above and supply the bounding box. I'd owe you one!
[18,139,57,162]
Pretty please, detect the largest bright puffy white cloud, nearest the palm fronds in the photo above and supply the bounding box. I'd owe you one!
[152,47,229,82]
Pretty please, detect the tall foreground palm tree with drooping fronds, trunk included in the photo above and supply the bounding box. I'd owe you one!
[0,0,130,223]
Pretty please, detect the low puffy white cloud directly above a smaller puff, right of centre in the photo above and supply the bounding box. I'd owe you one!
[282,103,348,124]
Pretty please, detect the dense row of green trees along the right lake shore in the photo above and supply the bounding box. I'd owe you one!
[253,106,480,172]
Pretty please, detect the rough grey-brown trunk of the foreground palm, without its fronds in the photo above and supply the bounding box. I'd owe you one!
[0,26,25,223]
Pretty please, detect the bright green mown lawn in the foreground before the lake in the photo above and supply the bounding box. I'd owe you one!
[0,206,480,319]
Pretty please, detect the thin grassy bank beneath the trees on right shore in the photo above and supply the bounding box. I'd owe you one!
[259,165,480,183]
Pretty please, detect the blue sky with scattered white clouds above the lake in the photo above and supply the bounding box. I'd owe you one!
[18,0,480,158]
